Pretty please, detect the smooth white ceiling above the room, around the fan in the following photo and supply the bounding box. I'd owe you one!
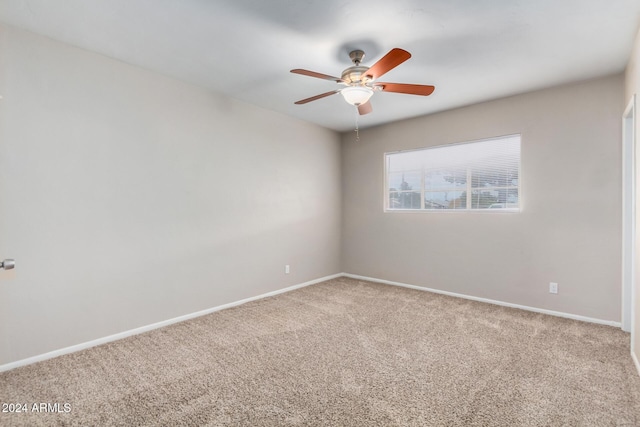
[0,0,640,131]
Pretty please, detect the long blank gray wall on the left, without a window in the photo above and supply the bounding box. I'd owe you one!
[0,26,341,365]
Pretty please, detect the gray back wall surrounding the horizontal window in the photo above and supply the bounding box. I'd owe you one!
[342,75,624,322]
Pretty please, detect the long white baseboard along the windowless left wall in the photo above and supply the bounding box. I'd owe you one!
[0,273,343,372]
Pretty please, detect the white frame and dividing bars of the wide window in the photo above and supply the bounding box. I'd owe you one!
[383,133,523,213]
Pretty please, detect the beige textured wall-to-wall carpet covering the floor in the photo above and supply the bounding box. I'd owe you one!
[0,278,640,426]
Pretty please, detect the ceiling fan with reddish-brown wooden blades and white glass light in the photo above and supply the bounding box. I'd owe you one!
[291,48,435,115]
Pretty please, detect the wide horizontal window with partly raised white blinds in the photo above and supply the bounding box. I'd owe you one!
[385,135,521,211]
